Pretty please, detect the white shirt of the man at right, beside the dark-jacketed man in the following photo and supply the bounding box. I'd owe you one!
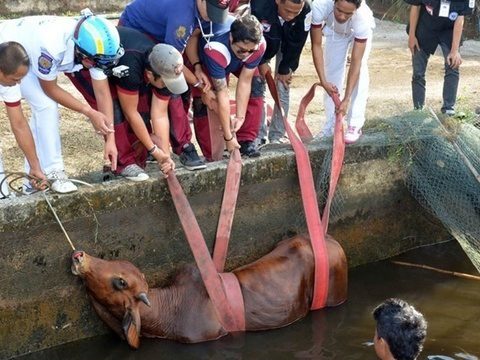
[312,0,375,40]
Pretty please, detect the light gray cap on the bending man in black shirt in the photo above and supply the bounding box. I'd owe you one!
[148,44,188,94]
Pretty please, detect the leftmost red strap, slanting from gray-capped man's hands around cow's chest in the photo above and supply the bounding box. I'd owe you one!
[167,171,245,331]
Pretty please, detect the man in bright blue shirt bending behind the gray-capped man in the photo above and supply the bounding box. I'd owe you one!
[119,0,229,170]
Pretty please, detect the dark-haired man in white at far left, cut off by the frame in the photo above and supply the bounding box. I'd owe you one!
[0,41,46,199]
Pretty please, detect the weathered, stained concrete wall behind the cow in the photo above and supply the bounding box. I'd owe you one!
[0,136,448,359]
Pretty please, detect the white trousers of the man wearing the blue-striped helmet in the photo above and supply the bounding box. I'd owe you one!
[20,71,64,174]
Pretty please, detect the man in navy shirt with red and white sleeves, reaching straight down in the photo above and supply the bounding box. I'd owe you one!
[194,15,266,159]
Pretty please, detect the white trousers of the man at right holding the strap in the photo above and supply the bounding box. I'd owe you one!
[323,31,372,134]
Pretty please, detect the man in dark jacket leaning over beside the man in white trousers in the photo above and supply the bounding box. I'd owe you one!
[250,0,312,144]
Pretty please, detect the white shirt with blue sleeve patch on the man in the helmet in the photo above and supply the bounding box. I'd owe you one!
[0,16,107,80]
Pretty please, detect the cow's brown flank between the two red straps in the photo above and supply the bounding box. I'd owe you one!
[234,236,314,330]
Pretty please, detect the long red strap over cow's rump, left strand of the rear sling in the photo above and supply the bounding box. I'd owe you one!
[265,73,329,310]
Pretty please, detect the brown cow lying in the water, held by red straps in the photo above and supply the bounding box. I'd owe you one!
[72,236,347,348]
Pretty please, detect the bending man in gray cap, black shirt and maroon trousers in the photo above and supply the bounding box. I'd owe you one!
[70,26,188,181]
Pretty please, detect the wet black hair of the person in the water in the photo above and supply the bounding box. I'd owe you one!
[373,299,427,360]
